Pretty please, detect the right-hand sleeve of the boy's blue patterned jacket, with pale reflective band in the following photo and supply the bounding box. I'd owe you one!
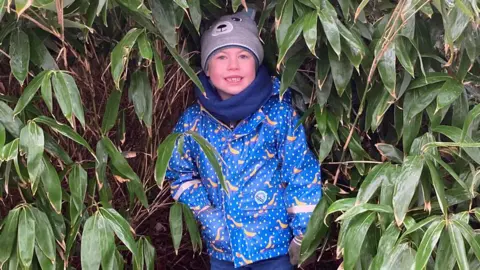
[280,109,322,236]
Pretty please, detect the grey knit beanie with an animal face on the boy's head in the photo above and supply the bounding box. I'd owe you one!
[201,12,263,70]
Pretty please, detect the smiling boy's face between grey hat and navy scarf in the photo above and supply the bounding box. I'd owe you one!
[206,47,256,100]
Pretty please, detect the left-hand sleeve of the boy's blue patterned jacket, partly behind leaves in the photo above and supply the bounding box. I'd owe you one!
[166,112,228,250]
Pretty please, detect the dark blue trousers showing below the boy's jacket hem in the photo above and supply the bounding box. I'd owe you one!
[210,255,293,270]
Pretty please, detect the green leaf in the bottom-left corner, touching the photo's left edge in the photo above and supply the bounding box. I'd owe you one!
[0,208,20,267]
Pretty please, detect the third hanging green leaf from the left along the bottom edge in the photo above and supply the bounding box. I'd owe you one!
[31,207,56,265]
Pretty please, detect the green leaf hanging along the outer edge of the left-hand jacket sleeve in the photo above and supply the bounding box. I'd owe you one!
[155,133,182,188]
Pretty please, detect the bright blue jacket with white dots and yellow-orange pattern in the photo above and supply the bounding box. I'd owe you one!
[167,78,322,267]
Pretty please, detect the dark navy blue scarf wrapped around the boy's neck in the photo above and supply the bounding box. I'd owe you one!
[195,66,273,124]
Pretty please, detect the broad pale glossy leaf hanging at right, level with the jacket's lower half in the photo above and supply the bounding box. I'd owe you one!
[393,156,424,226]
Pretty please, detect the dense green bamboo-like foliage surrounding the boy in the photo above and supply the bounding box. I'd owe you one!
[0,0,480,269]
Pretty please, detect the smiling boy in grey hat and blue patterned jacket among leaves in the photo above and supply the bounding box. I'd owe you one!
[167,13,321,270]
